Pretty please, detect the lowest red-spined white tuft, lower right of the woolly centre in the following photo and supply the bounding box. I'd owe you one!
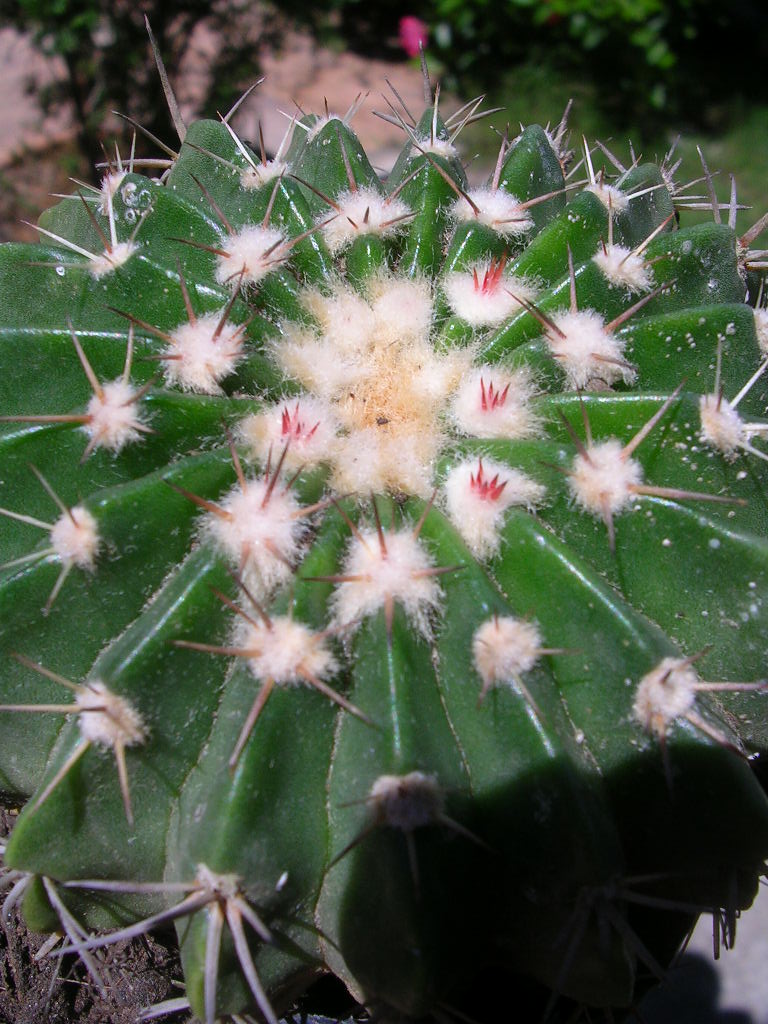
[444,459,545,558]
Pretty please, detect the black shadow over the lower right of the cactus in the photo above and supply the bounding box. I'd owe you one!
[323,739,768,1024]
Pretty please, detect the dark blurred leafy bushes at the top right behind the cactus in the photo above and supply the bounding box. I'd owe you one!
[296,0,768,131]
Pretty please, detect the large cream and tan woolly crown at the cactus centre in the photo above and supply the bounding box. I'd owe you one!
[276,278,471,497]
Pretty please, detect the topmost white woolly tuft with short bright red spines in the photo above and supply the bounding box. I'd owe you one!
[442,260,537,327]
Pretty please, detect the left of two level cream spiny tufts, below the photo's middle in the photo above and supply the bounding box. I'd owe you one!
[234,615,339,686]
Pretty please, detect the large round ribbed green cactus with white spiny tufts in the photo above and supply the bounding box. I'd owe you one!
[0,48,768,1022]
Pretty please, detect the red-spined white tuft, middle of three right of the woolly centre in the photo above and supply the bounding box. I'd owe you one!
[452,365,539,437]
